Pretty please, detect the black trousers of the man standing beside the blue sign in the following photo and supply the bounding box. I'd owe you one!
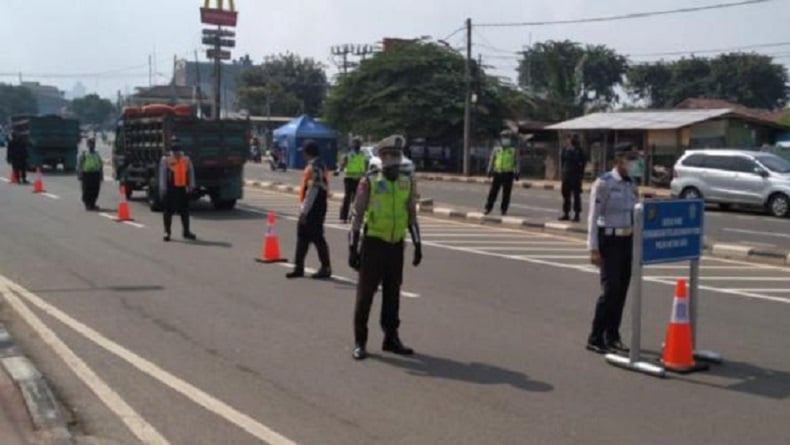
[590,230,633,341]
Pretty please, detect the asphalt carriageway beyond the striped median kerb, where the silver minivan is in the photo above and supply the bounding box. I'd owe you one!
[244,160,790,250]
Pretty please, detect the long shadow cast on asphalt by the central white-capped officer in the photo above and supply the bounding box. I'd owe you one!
[371,354,554,392]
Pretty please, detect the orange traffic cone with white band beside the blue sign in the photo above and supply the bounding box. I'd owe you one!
[661,279,700,373]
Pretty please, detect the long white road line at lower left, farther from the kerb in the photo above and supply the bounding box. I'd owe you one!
[0,275,296,445]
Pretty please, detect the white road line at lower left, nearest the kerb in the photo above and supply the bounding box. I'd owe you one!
[0,276,169,445]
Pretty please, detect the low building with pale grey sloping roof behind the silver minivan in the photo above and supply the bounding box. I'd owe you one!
[547,108,790,179]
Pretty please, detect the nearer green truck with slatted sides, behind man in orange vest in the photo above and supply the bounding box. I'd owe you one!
[112,104,250,211]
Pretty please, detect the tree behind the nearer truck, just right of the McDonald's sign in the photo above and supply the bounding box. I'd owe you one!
[236,54,329,116]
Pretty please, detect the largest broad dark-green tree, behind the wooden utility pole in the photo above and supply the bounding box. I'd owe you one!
[324,40,508,144]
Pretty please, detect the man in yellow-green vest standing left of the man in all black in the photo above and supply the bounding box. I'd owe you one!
[485,129,521,215]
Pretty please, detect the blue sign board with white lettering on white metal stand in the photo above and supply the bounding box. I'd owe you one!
[606,199,721,377]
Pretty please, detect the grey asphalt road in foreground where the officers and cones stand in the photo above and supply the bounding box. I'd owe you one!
[0,165,790,445]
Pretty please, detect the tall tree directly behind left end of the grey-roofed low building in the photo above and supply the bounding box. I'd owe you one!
[518,40,628,120]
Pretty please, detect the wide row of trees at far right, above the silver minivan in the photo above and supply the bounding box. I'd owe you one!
[626,53,789,109]
